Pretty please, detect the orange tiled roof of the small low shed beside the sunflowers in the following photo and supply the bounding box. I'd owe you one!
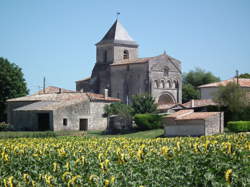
[166,110,220,120]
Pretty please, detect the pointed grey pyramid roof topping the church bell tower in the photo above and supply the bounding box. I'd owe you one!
[96,20,137,45]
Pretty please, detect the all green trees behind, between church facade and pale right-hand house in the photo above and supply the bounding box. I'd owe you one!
[182,68,220,102]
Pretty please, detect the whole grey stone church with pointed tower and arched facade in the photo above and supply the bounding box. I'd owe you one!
[76,20,182,105]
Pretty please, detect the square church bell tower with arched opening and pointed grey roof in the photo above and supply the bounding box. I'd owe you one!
[96,20,138,64]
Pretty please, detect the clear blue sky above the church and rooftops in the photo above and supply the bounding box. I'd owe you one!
[0,0,250,93]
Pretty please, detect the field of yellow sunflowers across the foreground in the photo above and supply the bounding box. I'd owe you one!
[0,133,250,187]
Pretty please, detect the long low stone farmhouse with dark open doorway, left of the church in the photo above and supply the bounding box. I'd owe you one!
[7,87,120,131]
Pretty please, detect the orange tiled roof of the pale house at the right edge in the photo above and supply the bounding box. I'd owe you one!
[198,78,250,88]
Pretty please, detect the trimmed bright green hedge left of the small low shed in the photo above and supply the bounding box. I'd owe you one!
[134,114,162,130]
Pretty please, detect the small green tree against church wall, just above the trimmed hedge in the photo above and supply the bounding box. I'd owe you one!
[132,94,157,114]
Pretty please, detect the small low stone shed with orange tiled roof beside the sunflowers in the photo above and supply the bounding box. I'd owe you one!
[163,110,224,136]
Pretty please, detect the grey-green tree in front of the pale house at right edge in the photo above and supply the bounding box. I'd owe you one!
[213,82,249,120]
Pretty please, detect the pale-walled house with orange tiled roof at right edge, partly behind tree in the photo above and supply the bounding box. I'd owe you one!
[198,78,250,99]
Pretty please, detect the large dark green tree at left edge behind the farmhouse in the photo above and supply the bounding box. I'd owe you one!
[0,57,28,121]
